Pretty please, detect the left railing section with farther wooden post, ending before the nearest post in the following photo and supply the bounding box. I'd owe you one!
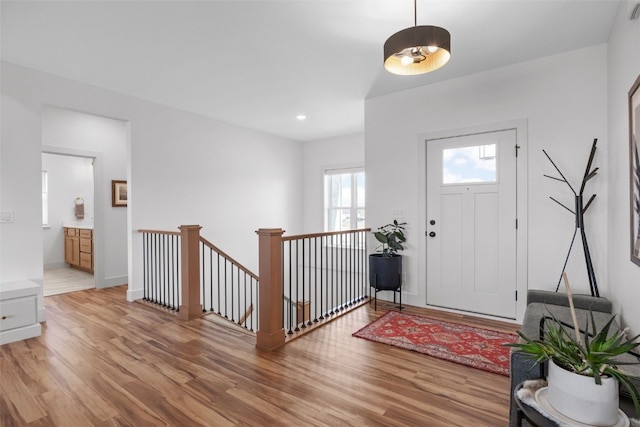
[139,225,258,332]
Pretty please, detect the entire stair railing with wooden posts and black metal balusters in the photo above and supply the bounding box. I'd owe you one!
[139,225,371,350]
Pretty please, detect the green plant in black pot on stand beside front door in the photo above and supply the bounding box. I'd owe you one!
[369,219,407,305]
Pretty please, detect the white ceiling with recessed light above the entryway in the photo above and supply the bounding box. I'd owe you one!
[1,0,620,141]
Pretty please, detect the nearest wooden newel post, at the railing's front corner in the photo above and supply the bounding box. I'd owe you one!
[256,228,285,350]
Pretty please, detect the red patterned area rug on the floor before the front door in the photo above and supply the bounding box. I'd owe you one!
[353,311,518,377]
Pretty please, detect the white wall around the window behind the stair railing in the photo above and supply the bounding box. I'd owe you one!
[302,134,366,233]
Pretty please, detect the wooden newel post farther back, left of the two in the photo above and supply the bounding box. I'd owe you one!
[178,225,202,320]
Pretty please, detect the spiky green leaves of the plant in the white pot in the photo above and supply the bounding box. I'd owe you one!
[505,307,640,420]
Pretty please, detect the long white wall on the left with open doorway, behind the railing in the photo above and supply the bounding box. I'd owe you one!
[0,62,302,303]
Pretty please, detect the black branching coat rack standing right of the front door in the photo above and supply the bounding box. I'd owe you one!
[542,138,600,297]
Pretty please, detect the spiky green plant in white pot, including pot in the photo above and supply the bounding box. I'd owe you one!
[505,304,640,425]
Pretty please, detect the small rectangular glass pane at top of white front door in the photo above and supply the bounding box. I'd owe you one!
[442,144,498,184]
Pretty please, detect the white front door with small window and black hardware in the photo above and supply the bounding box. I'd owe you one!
[426,129,517,318]
